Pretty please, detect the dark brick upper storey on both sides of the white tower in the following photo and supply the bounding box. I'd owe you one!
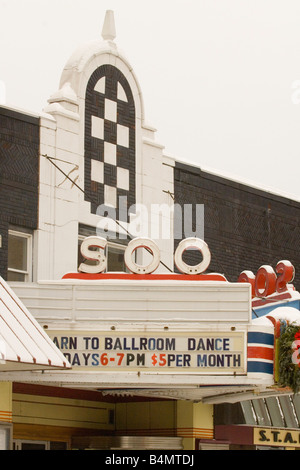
[0,103,300,290]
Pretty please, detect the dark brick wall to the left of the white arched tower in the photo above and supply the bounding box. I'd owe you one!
[0,107,39,279]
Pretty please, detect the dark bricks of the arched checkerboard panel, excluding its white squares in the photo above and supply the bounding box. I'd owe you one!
[84,65,136,222]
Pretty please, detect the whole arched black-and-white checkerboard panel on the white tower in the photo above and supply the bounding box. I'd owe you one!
[85,65,136,222]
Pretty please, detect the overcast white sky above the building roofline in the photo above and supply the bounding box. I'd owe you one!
[0,0,300,200]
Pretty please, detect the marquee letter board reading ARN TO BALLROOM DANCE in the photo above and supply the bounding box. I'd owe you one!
[49,331,247,375]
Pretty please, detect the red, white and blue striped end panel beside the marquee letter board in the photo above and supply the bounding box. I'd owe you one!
[247,331,274,375]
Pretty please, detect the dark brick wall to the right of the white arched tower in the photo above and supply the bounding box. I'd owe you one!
[174,163,300,290]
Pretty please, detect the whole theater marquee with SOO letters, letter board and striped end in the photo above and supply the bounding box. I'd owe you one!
[7,237,274,399]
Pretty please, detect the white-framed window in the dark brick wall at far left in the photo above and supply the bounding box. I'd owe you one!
[7,230,32,282]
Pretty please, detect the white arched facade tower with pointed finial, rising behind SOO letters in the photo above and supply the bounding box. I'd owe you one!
[38,13,174,279]
